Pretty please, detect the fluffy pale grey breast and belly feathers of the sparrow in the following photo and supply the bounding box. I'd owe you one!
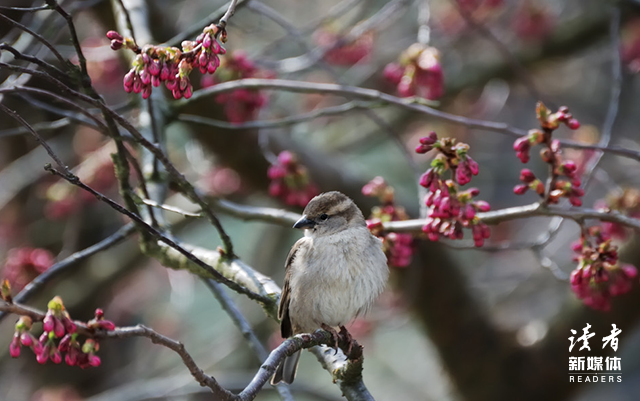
[290,227,389,330]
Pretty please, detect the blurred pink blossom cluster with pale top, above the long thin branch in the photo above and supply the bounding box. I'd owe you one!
[384,43,444,100]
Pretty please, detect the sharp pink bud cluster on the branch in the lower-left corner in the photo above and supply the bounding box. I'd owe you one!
[9,296,115,369]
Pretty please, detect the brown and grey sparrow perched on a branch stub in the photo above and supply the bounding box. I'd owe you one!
[271,191,389,385]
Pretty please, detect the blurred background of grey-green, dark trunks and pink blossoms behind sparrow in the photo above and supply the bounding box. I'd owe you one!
[0,0,640,401]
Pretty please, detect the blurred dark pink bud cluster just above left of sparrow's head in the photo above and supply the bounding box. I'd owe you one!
[267,150,319,207]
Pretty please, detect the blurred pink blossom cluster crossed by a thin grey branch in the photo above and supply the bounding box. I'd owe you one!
[201,50,273,124]
